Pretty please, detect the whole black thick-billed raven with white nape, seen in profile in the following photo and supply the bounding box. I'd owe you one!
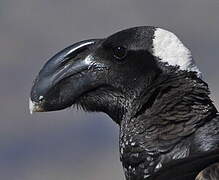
[30,26,219,180]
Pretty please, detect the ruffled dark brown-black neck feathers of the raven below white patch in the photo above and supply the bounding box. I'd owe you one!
[120,71,217,178]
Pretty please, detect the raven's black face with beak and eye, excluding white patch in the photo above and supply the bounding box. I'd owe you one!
[30,27,161,114]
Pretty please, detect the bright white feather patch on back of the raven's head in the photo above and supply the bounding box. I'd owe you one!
[153,28,201,77]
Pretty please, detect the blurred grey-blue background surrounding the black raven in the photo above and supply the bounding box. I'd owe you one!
[0,0,219,180]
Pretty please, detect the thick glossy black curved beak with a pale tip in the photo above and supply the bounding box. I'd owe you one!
[29,39,102,114]
